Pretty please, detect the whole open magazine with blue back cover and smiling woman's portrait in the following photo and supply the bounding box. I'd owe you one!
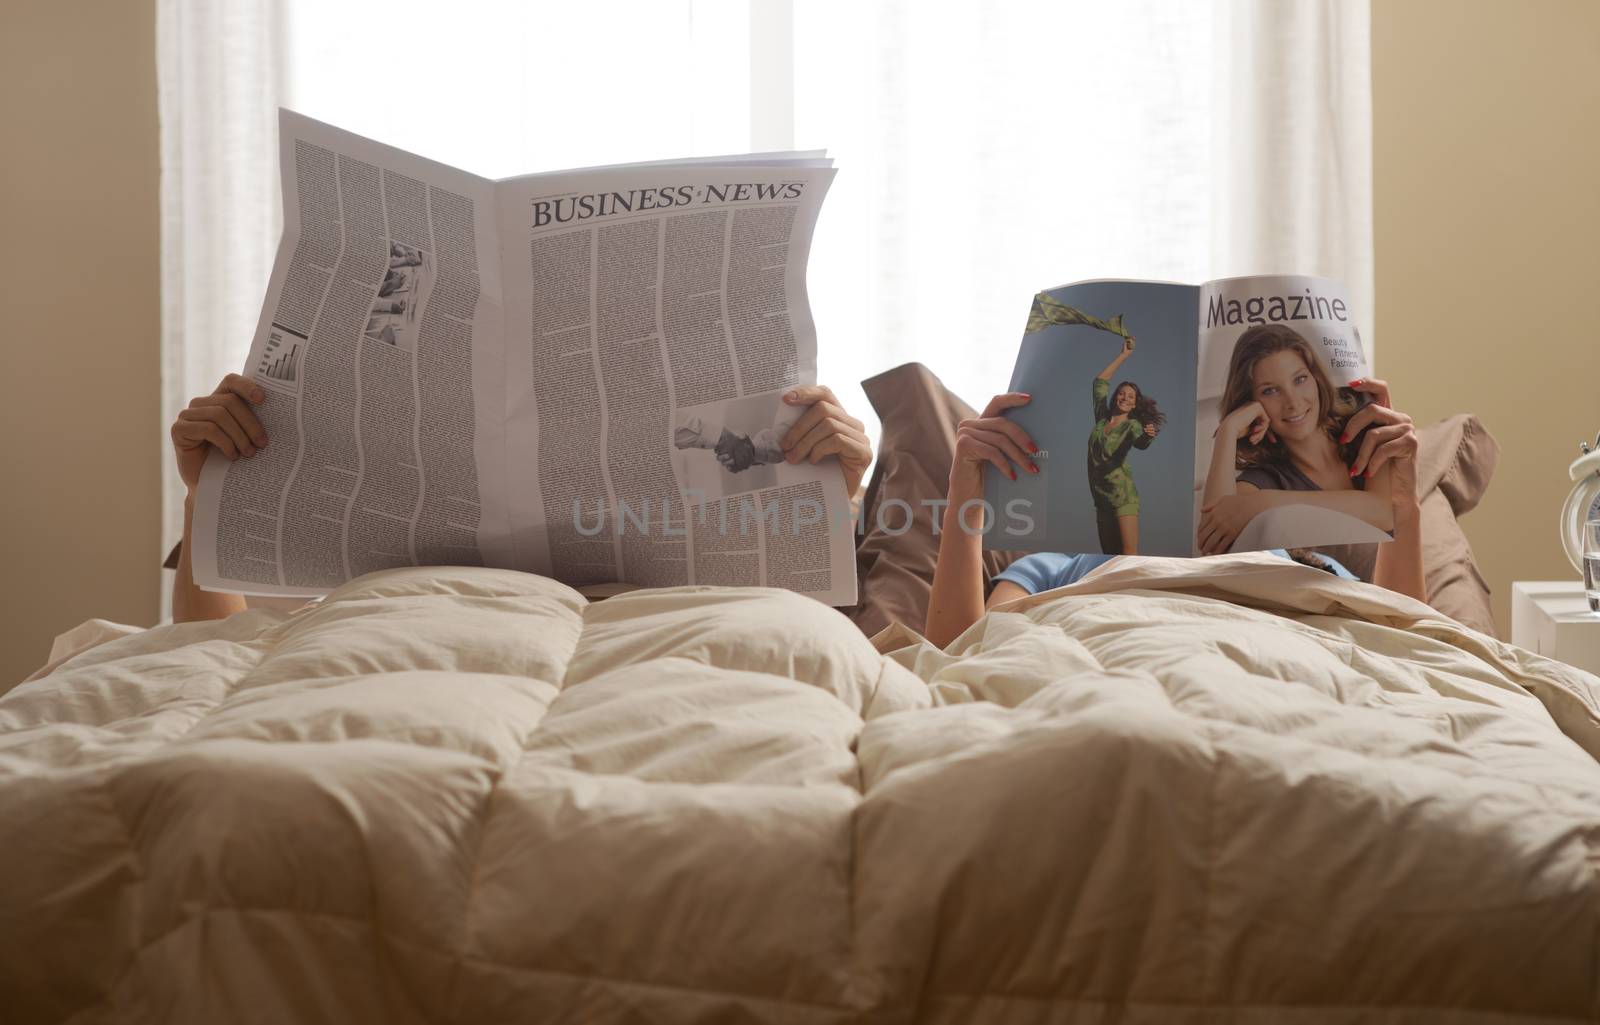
[984,275,1392,555]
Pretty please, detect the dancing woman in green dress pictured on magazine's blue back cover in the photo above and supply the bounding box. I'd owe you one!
[1088,334,1166,555]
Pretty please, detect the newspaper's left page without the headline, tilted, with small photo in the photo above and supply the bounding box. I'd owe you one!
[190,110,510,595]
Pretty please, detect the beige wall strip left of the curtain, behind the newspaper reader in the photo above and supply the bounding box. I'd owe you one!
[0,0,165,691]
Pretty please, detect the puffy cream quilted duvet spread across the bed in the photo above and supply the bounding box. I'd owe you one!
[0,556,1600,1025]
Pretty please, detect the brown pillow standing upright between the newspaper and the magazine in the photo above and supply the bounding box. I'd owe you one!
[848,363,1022,636]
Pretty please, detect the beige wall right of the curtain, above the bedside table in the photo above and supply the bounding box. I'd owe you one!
[1373,0,1600,636]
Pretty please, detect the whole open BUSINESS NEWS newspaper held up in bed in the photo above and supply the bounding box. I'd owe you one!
[192,110,856,604]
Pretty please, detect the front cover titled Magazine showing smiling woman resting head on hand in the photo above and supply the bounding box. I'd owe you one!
[1192,275,1392,555]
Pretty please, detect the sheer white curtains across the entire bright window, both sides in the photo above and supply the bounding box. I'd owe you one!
[158,0,1373,601]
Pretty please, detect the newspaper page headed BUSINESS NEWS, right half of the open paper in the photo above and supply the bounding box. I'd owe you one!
[496,161,856,604]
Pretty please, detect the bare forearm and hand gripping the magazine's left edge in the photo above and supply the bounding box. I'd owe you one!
[923,393,1038,648]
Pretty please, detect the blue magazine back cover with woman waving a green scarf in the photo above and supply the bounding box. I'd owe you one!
[984,281,1198,555]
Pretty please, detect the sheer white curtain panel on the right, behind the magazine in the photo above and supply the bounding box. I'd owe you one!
[794,0,1373,434]
